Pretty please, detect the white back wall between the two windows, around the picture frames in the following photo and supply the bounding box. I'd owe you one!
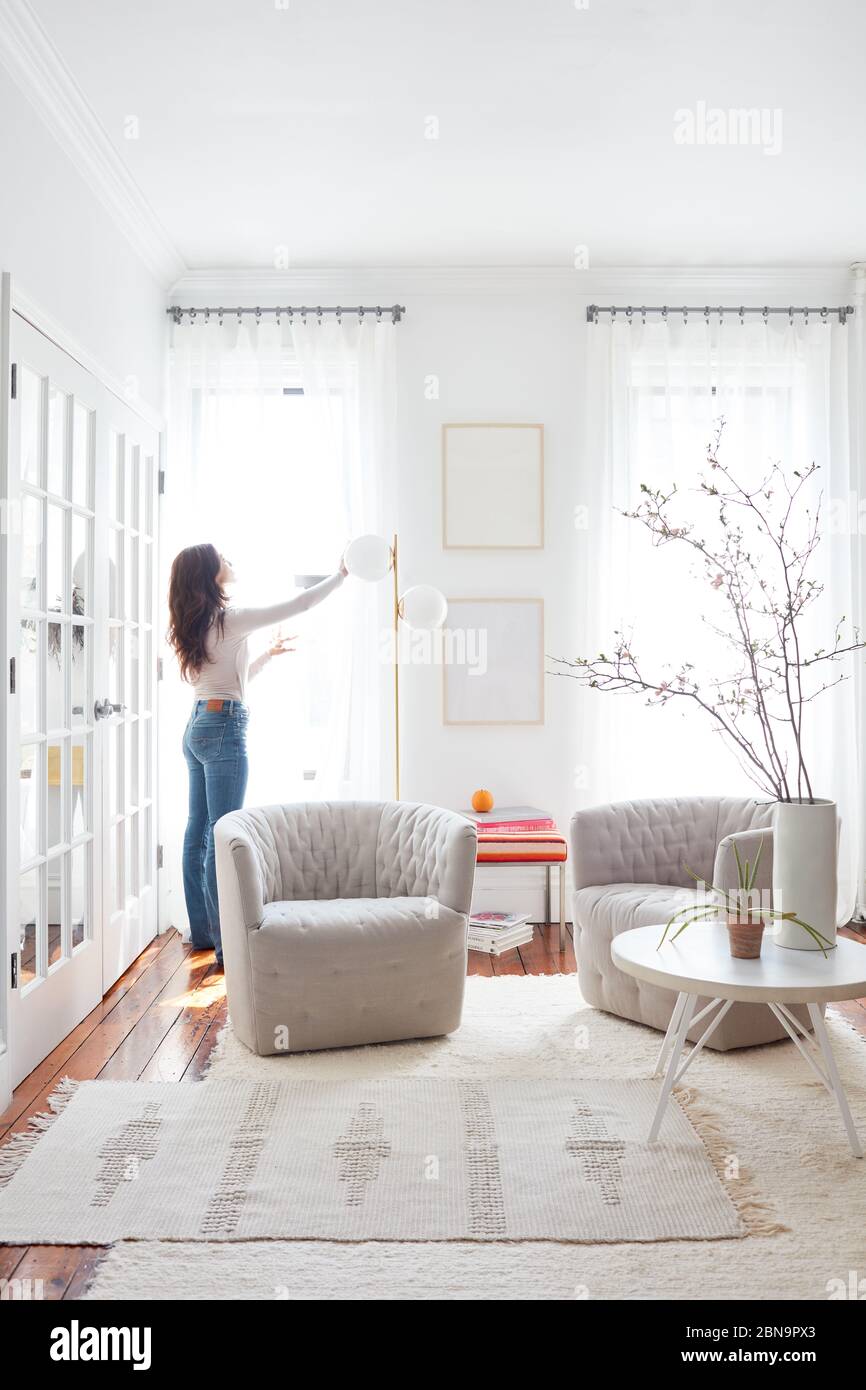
[398,292,585,912]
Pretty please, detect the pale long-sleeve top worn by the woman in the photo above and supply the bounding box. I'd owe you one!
[192,571,343,701]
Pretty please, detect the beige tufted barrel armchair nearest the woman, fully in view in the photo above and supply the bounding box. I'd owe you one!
[214,802,475,1056]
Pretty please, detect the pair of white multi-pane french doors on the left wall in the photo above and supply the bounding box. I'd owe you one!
[4,313,158,1086]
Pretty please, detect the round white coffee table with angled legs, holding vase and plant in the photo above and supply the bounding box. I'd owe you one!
[610,922,866,1158]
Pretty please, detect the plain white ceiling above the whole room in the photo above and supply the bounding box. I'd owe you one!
[32,0,866,268]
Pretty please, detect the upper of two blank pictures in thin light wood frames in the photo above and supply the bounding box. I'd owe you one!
[442,424,545,550]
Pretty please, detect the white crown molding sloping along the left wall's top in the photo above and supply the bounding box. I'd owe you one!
[0,0,186,285]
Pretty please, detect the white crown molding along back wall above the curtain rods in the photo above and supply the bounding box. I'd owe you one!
[170,265,852,307]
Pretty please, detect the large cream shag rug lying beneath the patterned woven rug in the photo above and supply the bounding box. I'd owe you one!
[79,976,866,1300]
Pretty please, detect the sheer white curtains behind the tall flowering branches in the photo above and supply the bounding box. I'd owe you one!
[580,314,863,916]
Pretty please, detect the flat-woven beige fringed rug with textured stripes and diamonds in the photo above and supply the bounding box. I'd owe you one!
[0,1077,746,1244]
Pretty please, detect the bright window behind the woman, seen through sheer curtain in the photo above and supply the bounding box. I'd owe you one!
[190,385,348,803]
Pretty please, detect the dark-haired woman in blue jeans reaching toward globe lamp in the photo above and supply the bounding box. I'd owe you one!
[168,545,346,965]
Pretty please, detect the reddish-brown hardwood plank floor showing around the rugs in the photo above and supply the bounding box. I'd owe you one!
[0,926,866,1298]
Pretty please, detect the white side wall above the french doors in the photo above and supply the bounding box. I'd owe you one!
[0,68,165,411]
